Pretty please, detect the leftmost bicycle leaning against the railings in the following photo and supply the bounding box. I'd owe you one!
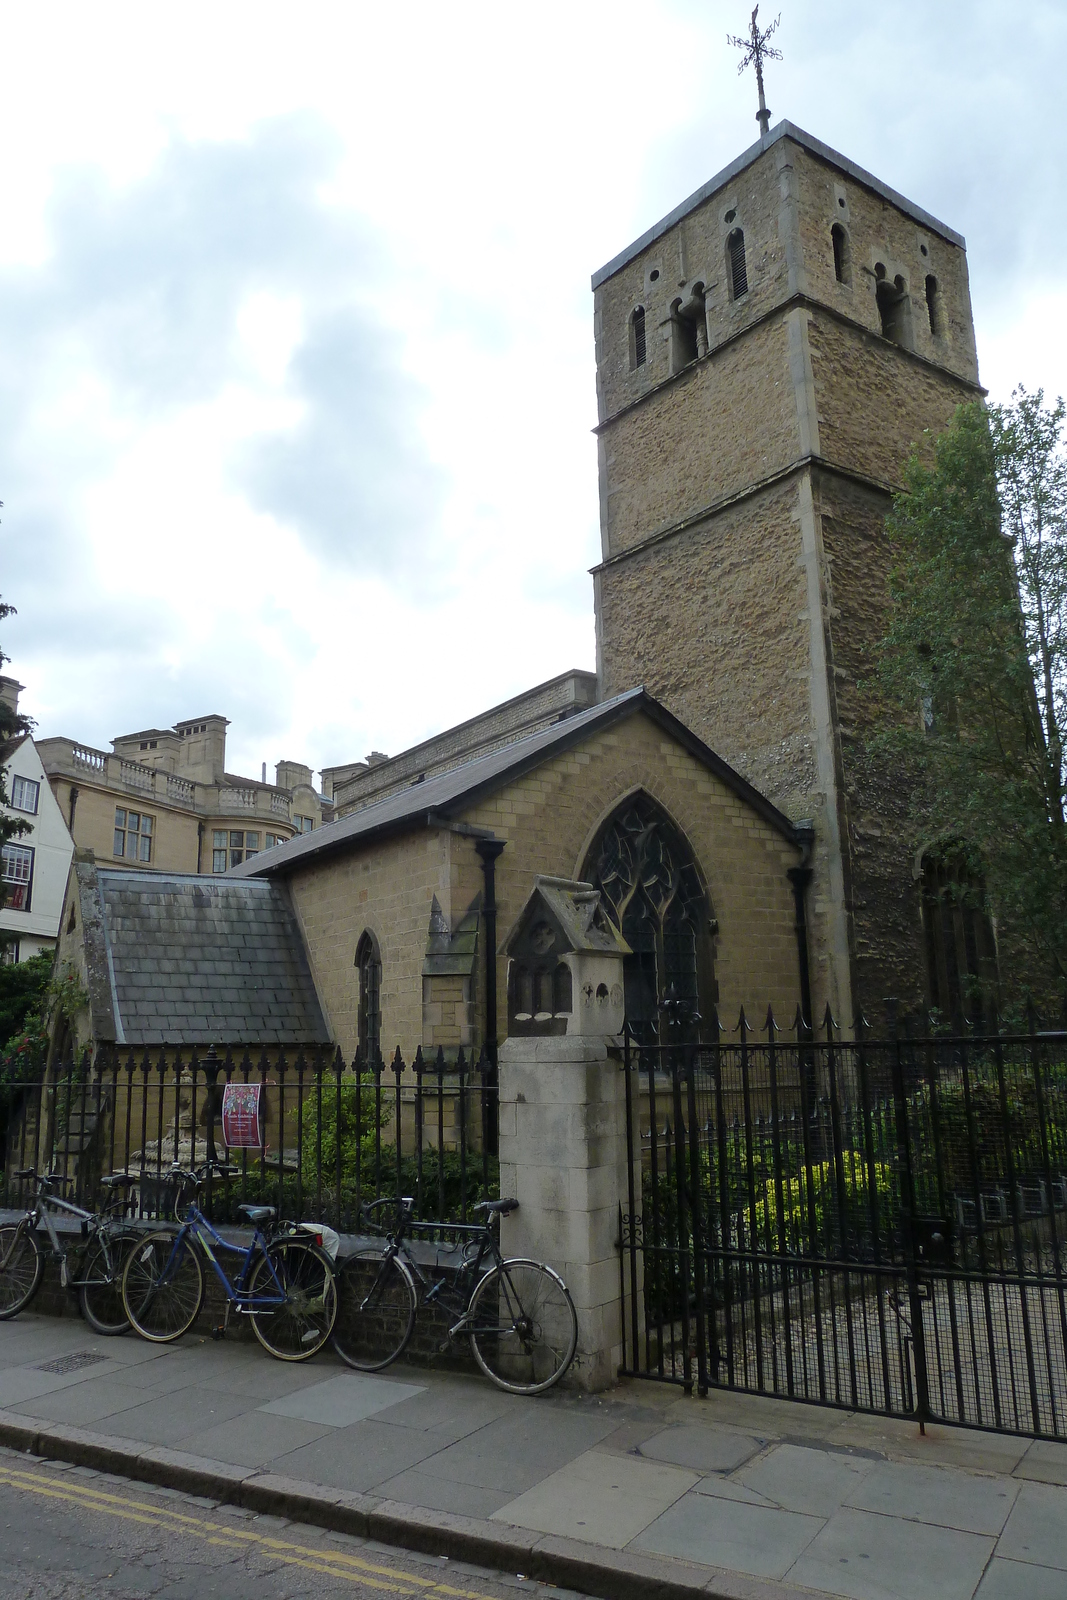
[0,1166,139,1334]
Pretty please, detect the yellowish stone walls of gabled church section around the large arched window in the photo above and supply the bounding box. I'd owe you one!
[283,714,800,1059]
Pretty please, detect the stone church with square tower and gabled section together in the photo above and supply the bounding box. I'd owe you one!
[51,122,982,1059]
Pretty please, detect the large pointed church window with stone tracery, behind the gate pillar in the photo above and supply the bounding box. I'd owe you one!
[582,794,713,1038]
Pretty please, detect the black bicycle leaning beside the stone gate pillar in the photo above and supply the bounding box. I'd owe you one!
[333,1195,577,1395]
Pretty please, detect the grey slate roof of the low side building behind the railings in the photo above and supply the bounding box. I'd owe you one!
[78,862,330,1046]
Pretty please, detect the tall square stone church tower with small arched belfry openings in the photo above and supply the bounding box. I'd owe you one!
[593,122,982,1029]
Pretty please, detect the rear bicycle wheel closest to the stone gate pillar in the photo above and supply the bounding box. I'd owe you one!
[469,1258,577,1395]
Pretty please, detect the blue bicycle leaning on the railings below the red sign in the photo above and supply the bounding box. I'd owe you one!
[122,1162,338,1362]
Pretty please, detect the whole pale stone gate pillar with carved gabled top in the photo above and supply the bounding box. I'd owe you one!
[499,878,629,1389]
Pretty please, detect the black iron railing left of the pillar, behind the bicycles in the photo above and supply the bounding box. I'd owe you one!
[0,1048,499,1230]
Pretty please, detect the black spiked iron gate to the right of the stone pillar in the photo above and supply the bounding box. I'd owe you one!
[619,1013,1067,1438]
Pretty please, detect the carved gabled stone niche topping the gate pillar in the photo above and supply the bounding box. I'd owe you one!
[501,877,630,1037]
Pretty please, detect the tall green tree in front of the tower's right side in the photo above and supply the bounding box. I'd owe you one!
[875,390,1067,992]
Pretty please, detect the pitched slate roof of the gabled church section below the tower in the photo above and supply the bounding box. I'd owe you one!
[227,688,801,880]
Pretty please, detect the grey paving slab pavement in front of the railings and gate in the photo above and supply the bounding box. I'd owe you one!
[0,1314,1067,1600]
